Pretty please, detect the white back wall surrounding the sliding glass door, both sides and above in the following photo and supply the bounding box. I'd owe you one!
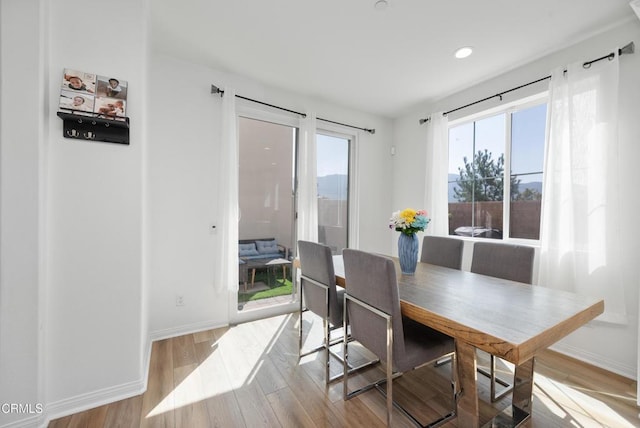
[148,54,392,337]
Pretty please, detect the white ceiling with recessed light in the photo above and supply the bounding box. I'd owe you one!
[149,0,635,117]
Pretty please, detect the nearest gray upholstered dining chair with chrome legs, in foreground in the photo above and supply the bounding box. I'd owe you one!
[343,249,456,426]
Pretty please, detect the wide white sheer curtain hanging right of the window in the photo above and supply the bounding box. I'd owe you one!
[539,56,630,323]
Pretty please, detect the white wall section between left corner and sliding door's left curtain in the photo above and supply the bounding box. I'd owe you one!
[148,56,228,337]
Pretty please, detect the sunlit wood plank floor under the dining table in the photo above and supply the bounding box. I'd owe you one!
[49,314,640,428]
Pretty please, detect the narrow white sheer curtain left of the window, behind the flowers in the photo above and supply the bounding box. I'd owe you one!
[424,112,449,236]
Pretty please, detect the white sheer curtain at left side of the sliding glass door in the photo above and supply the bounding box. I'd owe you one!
[219,88,239,292]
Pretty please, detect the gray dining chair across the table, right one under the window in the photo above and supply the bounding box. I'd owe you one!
[471,242,535,402]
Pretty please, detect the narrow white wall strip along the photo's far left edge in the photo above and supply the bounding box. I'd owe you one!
[0,0,48,425]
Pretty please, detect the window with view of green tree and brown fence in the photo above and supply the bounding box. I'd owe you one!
[448,103,547,240]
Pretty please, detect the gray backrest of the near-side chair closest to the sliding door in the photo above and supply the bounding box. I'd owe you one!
[298,241,343,326]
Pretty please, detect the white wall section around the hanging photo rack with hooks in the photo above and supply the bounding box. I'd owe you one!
[45,0,148,416]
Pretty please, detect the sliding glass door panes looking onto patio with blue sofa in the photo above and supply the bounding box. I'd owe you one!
[233,115,353,322]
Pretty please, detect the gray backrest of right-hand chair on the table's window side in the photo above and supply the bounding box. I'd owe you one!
[471,242,534,284]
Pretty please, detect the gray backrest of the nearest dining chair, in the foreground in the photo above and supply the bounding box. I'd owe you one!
[342,249,404,366]
